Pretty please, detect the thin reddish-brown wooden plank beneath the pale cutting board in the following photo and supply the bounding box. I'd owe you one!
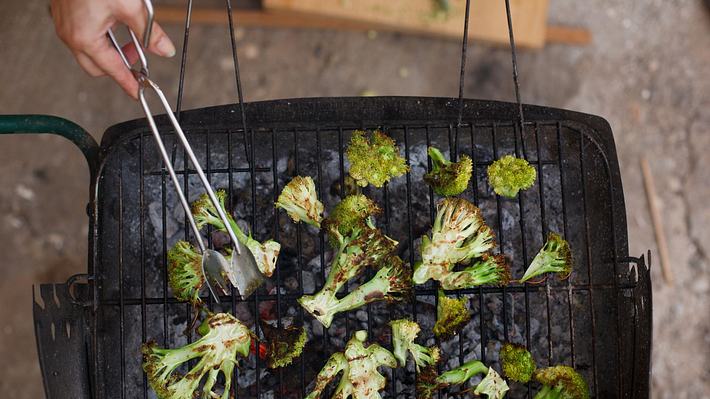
[155,6,591,46]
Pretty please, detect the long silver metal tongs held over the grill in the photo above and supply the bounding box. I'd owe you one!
[108,0,264,303]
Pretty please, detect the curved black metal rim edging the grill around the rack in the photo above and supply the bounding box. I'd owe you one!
[79,97,651,397]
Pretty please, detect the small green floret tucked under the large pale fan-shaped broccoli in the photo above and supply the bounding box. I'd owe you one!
[441,254,510,290]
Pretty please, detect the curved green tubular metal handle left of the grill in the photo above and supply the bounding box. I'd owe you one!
[0,115,100,181]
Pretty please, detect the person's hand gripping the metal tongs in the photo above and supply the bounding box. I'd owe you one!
[51,0,175,98]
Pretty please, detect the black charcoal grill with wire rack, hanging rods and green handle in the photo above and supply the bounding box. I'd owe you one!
[0,1,651,398]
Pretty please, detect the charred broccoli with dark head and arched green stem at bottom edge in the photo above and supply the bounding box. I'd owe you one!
[417,360,508,399]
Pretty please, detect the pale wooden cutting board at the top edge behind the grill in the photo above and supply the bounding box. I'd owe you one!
[262,0,549,48]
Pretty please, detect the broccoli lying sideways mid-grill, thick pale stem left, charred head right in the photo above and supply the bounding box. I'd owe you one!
[298,256,412,328]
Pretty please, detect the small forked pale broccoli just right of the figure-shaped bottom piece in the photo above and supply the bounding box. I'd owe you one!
[390,319,439,371]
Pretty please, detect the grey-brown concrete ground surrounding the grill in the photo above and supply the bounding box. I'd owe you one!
[0,0,710,399]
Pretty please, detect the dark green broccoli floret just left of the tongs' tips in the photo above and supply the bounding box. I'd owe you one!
[168,241,205,306]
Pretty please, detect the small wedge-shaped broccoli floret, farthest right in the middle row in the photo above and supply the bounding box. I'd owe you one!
[520,233,573,283]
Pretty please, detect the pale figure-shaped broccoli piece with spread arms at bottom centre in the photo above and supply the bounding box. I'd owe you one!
[306,331,397,399]
